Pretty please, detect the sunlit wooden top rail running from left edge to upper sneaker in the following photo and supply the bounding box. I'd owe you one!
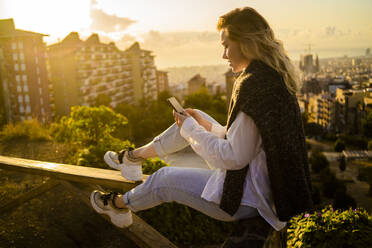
[0,156,148,192]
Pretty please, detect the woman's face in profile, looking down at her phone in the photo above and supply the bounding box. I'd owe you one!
[220,29,250,73]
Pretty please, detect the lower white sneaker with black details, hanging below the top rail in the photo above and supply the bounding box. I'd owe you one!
[90,190,133,228]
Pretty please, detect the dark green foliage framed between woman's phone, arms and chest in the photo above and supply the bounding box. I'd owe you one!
[184,88,227,125]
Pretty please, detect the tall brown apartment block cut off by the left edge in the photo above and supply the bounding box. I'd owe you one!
[0,19,53,122]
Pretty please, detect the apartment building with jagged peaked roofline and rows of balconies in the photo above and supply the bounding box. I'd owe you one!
[48,32,135,116]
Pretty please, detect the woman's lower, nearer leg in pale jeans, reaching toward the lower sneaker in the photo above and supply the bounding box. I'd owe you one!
[120,167,258,221]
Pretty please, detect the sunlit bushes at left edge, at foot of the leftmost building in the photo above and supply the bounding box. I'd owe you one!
[0,119,51,141]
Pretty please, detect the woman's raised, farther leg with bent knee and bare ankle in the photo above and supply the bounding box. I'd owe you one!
[133,110,218,158]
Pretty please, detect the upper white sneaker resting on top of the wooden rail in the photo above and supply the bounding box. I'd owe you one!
[104,148,143,181]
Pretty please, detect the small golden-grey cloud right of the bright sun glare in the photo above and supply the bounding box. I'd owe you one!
[90,7,136,33]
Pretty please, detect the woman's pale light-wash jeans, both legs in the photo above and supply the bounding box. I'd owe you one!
[123,110,259,221]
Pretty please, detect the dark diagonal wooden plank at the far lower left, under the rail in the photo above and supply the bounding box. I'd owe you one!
[0,180,59,215]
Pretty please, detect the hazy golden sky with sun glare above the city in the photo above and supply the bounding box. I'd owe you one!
[0,0,372,69]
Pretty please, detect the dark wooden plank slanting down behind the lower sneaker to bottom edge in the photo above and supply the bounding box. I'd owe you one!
[63,182,177,248]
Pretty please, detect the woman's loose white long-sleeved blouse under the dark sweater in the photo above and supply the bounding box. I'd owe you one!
[180,111,286,231]
